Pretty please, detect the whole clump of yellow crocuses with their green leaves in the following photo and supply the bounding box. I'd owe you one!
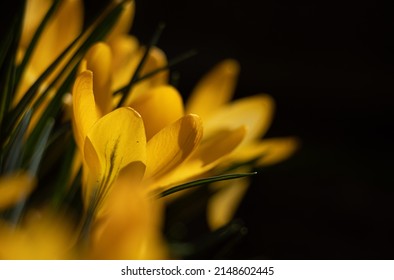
[0,0,297,259]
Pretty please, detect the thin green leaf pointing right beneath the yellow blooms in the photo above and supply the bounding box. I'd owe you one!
[159,172,257,197]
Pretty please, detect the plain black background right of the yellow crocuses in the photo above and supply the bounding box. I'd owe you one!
[124,0,394,259]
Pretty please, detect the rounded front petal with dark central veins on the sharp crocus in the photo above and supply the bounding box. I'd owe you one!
[85,107,146,208]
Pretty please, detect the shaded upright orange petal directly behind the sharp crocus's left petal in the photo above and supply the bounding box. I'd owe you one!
[85,42,112,116]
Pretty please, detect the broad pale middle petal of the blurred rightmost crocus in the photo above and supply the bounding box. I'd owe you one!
[204,94,274,143]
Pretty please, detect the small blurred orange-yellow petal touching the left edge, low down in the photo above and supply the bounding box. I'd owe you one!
[0,173,36,210]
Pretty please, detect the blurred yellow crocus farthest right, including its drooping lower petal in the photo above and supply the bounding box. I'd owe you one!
[186,59,298,229]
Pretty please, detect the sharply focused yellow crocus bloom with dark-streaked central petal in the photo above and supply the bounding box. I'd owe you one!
[73,71,202,210]
